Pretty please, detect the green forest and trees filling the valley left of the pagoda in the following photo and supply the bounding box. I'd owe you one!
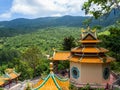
[0,27,80,80]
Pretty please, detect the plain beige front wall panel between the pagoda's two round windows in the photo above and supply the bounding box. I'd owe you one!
[81,64,102,83]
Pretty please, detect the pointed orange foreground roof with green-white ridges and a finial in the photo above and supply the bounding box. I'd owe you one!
[32,63,69,90]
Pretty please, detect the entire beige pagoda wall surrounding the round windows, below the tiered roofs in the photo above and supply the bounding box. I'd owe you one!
[70,62,109,84]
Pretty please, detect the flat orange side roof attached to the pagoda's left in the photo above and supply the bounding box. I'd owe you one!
[52,52,71,60]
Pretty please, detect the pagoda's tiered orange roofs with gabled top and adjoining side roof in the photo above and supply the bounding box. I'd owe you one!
[51,28,114,63]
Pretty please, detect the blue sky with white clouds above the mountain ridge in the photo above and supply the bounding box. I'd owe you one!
[0,0,86,21]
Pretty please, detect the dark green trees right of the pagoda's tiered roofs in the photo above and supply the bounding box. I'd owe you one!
[100,26,120,61]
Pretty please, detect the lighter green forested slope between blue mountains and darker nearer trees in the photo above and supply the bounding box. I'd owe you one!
[3,27,80,53]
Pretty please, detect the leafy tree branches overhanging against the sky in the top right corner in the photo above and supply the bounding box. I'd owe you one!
[82,0,120,18]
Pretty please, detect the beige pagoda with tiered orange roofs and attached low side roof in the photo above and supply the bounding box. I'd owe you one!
[50,28,114,86]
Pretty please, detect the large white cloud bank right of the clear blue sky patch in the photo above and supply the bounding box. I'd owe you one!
[11,0,85,16]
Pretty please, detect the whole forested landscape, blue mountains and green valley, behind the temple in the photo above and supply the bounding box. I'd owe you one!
[0,9,120,80]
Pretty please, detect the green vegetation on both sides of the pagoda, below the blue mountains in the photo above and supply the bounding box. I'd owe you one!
[0,14,120,80]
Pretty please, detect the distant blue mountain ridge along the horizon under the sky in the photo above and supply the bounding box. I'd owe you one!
[0,8,120,37]
